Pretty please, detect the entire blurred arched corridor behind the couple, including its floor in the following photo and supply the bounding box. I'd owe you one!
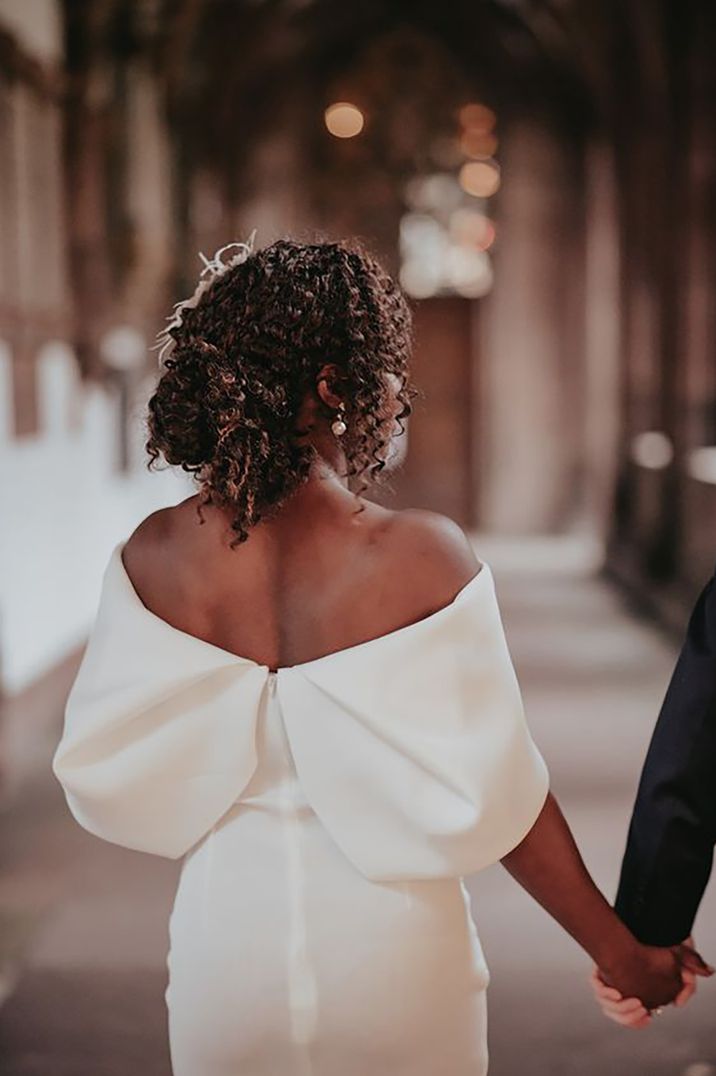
[0,0,716,1076]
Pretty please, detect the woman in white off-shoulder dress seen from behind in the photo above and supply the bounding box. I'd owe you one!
[53,236,710,1076]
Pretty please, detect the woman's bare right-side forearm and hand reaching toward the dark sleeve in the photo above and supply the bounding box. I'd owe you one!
[502,793,712,1009]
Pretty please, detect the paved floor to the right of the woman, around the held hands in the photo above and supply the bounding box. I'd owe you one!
[471,541,716,1076]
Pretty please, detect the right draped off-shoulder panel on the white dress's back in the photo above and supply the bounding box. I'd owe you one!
[279,566,549,881]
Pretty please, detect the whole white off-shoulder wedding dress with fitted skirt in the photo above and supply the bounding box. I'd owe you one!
[52,542,548,1076]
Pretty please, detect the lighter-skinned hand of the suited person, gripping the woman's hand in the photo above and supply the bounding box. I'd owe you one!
[589,937,714,1029]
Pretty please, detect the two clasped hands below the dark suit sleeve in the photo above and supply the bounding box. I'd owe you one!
[590,937,714,1029]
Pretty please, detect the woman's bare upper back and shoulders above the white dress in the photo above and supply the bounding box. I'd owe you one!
[123,487,480,668]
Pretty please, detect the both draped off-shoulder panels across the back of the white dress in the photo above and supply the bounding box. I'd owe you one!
[52,543,549,880]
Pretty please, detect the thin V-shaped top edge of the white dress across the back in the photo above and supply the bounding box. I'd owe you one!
[111,541,492,676]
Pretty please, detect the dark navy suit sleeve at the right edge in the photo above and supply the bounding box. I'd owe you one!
[615,576,716,946]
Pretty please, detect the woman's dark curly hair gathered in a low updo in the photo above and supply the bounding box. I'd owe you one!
[145,239,418,547]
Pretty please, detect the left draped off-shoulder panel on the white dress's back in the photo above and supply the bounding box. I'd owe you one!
[52,551,266,859]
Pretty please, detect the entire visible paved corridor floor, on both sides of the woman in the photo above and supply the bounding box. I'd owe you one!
[0,533,716,1076]
